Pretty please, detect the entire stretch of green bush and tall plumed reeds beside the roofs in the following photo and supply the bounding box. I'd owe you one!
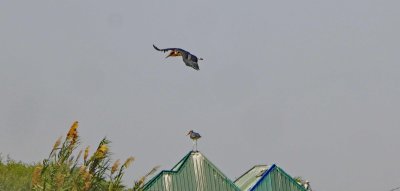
[0,122,157,191]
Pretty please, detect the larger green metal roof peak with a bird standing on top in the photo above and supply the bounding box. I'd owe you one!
[144,151,240,191]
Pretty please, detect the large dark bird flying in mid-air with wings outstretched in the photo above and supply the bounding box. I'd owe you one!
[153,44,203,70]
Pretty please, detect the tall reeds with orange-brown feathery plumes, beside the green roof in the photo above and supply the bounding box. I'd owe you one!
[32,122,153,191]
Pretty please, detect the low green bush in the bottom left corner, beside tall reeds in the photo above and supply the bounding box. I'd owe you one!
[0,155,34,191]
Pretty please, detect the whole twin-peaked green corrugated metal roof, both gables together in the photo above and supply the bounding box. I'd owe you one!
[143,151,306,191]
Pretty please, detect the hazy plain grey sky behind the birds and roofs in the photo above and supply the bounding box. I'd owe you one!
[0,0,400,191]
